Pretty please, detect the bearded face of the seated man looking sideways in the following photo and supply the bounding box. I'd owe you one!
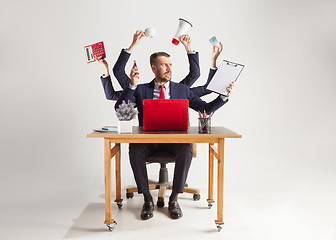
[152,56,172,83]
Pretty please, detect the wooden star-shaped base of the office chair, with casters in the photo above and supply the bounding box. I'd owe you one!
[126,180,201,208]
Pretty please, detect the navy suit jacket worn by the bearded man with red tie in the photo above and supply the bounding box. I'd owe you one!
[115,80,228,126]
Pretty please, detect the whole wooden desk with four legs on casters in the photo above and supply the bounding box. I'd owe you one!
[87,127,242,231]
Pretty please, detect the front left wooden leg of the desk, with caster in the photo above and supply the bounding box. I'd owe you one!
[104,139,115,226]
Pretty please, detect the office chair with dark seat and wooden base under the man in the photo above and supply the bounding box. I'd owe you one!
[126,143,201,208]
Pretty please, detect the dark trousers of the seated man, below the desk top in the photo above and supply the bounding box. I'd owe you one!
[129,143,192,193]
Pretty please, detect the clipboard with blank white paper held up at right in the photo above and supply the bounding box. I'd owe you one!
[207,60,245,95]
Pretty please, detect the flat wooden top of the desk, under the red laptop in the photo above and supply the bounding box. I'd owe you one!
[86,126,242,141]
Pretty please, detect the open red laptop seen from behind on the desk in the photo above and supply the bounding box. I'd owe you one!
[143,99,189,131]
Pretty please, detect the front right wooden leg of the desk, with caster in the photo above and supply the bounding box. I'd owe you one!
[215,138,224,231]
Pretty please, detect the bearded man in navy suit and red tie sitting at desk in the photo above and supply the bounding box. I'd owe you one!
[114,40,234,220]
